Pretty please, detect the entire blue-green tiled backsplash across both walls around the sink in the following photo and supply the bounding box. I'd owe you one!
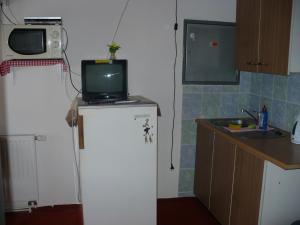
[179,72,300,196]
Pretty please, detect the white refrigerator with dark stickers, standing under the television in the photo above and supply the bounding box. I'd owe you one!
[78,99,157,225]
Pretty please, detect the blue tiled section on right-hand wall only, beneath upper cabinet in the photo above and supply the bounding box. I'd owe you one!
[249,74,300,131]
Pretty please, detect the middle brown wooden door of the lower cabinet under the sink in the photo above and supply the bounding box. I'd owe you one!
[210,133,236,225]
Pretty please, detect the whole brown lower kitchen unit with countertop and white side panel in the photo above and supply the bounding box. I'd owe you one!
[194,119,300,225]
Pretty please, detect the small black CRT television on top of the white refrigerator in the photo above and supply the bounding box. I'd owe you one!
[81,60,128,103]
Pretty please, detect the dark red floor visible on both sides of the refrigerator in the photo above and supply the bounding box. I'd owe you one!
[6,198,219,225]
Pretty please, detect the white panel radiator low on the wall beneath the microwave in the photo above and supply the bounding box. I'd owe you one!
[0,135,38,211]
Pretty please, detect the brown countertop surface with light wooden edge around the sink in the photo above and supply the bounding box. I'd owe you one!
[196,119,300,170]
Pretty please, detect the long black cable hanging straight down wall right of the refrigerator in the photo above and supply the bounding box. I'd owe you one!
[170,0,178,170]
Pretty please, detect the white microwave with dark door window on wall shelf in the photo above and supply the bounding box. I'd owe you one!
[1,24,62,60]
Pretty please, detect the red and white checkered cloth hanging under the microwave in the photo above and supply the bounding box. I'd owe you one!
[0,59,68,76]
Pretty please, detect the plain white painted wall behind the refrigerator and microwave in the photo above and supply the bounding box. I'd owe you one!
[0,0,236,203]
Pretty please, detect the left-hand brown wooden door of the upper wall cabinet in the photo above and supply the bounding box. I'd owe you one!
[236,0,260,72]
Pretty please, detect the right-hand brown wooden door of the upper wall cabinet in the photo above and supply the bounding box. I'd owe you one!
[258,0,292,74]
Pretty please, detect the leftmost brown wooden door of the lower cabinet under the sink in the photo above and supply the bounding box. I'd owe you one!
[194,123,214,208]
